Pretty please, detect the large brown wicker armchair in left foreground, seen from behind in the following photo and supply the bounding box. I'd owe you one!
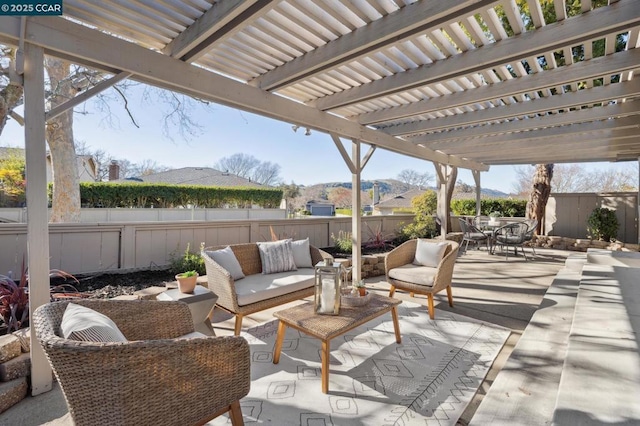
[33,299,251,426]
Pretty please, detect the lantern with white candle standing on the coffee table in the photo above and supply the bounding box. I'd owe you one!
[314,259,343,315]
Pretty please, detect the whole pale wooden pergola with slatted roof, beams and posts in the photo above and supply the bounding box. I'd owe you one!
[0,0,640,394]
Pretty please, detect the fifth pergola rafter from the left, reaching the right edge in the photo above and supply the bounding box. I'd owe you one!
[385,78,640,136]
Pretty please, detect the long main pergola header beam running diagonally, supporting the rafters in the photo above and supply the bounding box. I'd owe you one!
[0,16,488,170]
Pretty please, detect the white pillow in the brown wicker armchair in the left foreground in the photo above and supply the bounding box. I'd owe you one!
[60,303,127,342]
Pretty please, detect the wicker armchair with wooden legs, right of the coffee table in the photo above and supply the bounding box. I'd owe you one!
[384,240,459,319]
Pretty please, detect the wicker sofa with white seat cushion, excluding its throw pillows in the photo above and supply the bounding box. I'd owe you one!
[202,243,330,335]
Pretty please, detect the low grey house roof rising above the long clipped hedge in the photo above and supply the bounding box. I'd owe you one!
[112,167,264,187]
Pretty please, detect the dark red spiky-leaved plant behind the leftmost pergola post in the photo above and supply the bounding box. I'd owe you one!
[0,262,78,333]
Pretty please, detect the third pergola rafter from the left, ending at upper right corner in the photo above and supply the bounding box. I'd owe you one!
[311,0,640,110]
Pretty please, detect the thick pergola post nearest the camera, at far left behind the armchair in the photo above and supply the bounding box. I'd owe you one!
[24,43,52,396]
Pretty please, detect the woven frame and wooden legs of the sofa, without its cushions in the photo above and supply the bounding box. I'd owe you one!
[201,243,329,335]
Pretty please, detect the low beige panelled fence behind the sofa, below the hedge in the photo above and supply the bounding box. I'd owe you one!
[0,215,413,276]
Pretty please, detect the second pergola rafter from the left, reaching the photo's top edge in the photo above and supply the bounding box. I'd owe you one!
[253,0,498,90]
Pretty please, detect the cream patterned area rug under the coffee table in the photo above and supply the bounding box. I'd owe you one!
[210,302,510,426]
